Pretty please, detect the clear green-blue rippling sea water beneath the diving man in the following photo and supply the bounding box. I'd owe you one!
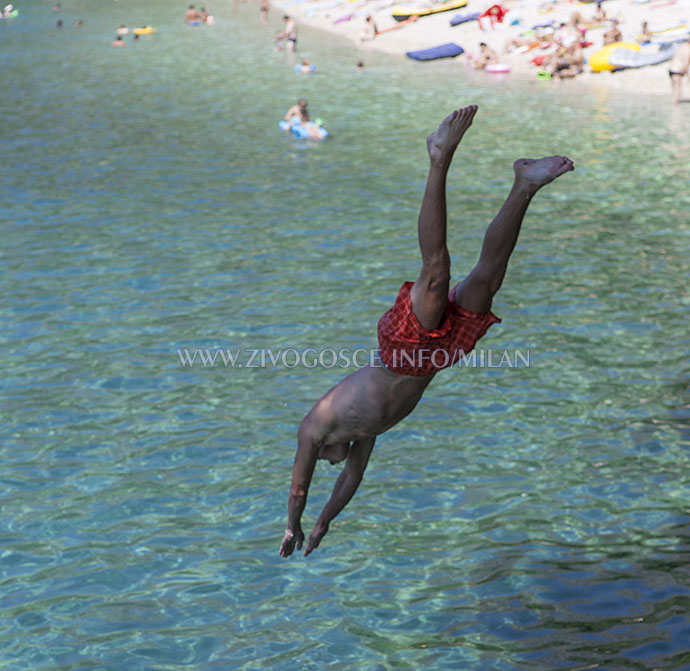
[0,0,690,671]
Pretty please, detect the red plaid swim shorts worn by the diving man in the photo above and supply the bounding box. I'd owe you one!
[378,282,501,377]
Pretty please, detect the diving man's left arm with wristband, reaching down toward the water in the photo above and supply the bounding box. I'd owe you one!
[279,421,319,557]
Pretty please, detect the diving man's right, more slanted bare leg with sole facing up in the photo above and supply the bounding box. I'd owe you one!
[454,156,574,312]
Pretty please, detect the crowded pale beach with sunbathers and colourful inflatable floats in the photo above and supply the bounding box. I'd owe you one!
[274,0,690,102]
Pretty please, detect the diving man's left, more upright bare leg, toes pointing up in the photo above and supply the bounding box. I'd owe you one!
[410,105,477,331]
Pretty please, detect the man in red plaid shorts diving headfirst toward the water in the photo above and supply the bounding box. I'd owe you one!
[279,105,573,557]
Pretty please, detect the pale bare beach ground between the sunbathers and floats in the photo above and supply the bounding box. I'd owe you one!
[274,0,690,100]
